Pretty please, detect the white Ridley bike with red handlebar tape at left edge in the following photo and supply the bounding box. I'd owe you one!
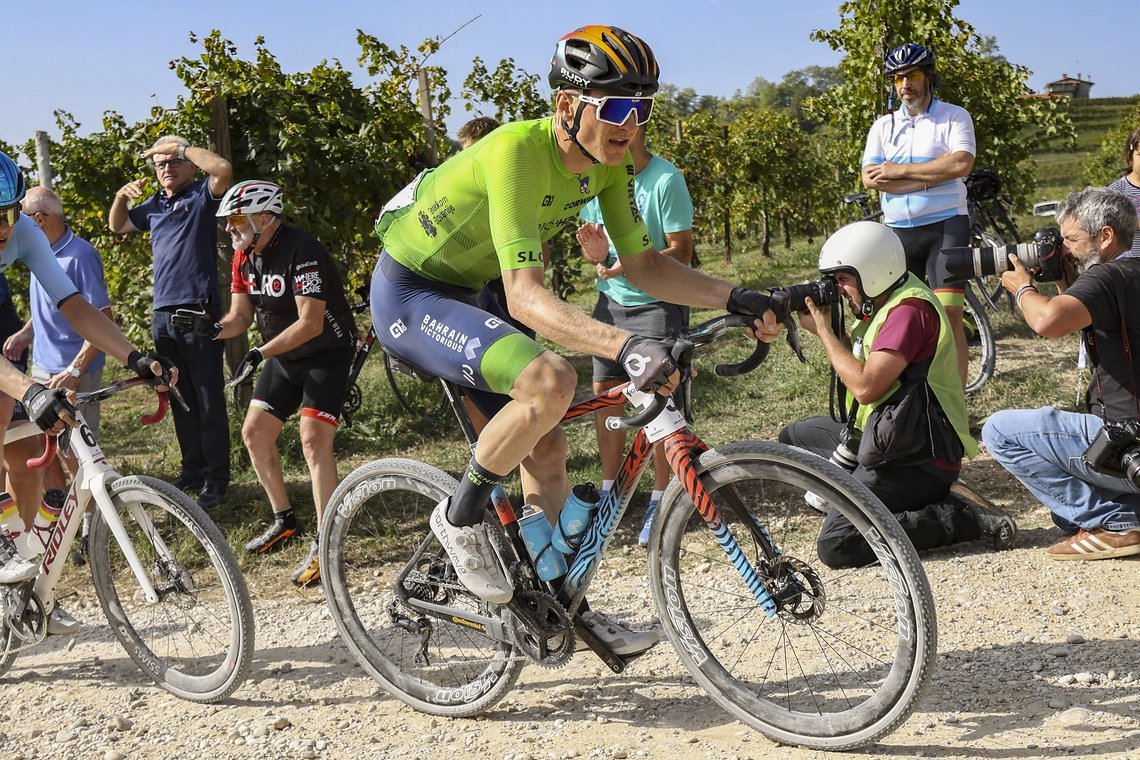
[0,377,254,702]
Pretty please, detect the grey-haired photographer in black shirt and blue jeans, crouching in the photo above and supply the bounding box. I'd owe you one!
[982,188,1140,559]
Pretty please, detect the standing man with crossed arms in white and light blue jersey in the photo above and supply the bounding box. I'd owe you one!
[862,42,977,386]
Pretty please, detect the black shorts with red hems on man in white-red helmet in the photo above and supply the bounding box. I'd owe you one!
[250,346,352,425]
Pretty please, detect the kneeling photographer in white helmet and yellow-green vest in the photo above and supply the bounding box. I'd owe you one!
[780,222,1017,567]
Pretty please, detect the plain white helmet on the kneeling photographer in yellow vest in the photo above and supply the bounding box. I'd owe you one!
[820,222,906,301]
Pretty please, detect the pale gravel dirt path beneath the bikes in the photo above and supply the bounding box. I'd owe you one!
[0,507,1140,760]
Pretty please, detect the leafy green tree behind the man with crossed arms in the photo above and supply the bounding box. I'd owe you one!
[806,0,1075,206]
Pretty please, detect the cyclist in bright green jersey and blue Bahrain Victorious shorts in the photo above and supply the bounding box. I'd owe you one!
[372,26,779,654]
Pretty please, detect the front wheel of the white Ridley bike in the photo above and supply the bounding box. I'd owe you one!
[90,476,254,702]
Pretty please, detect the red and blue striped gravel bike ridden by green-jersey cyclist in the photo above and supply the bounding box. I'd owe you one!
[320,316,937,750]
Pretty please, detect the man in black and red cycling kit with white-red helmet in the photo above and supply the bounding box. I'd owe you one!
[171,180,356,586]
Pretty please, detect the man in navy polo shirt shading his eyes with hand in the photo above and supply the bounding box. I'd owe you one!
[108,136,233,507]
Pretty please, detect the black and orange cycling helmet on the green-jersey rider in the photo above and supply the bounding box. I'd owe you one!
[546,24,660,97]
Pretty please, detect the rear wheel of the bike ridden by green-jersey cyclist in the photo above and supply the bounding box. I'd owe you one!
[320,459,523,718]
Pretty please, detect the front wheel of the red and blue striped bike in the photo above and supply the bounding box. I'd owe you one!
[649,442,937,750]
